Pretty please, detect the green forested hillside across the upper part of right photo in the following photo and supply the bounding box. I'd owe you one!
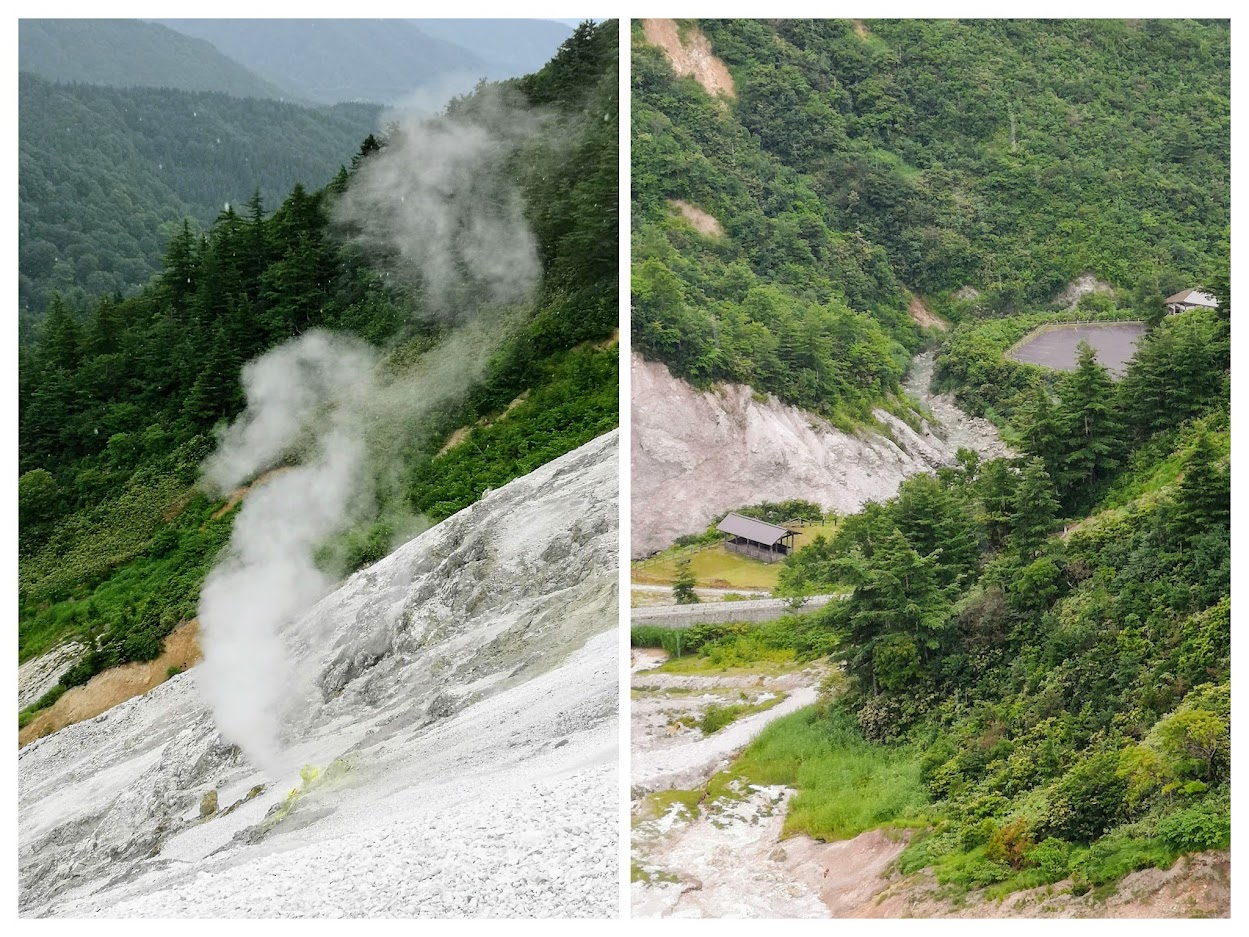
[633,20,1230,416]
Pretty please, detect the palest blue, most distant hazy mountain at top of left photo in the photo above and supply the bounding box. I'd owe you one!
[162,20,497,106]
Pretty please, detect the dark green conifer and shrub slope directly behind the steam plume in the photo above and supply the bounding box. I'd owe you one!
[19,22,618,724]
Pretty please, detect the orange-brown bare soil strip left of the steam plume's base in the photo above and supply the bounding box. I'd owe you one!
[17,618,204,748]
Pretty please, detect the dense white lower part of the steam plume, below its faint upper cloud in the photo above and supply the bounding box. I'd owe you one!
[196,331,376,772]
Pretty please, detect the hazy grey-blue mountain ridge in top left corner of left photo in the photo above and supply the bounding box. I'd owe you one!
[17,20,292,99]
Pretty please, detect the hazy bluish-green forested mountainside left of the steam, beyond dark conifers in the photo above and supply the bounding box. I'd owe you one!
[17,75,380,327]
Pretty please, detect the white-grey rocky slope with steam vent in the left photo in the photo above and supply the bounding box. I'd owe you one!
[19,432,618,917]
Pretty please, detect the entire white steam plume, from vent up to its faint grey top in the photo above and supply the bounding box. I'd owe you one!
[196,96,540,775]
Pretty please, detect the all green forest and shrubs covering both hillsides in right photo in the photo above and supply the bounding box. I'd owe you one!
[633,14,1230,900]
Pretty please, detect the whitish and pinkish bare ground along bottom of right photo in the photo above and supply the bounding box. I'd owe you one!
[631,648,1230,918]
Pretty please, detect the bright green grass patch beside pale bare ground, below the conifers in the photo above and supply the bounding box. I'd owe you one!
[733,702,928,841]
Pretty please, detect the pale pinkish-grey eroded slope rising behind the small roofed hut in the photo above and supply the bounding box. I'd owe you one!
[631,356,1003,557]
